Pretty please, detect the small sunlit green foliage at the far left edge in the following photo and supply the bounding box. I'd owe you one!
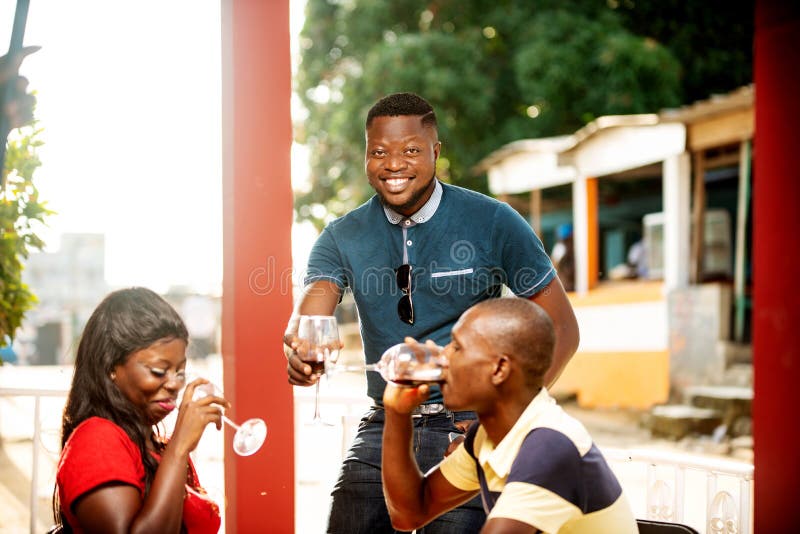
[0,123,52,364]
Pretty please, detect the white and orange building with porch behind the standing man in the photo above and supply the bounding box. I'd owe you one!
[476,86,755,408]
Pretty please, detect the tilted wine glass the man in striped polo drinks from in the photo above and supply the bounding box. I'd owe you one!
[327,343,448,387]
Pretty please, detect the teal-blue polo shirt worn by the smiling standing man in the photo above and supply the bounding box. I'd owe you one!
[304,184,556,402]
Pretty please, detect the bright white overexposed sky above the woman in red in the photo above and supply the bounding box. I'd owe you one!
[0,0,310,294]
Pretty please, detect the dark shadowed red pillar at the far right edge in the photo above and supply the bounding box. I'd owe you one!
[753,0,800,533]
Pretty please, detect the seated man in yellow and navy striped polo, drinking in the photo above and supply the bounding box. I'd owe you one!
[383,298,638,534]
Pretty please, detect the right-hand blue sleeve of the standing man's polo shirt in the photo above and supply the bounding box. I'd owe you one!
[492,204,556,298]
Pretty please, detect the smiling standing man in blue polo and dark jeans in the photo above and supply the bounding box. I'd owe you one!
[284,93,578,534]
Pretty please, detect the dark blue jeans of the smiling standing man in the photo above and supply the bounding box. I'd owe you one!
[328,407,486,534]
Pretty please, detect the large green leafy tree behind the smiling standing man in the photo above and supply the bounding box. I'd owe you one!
[296,0,752,227]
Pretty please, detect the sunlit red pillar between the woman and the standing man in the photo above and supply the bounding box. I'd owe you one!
[222,0,294,533]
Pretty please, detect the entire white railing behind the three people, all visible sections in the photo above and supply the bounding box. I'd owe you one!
[0,387,753,534]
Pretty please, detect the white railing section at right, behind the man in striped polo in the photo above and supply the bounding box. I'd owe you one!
[602,448,753,534]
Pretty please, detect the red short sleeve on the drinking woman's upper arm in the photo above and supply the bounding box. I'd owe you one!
[56,417,144,510]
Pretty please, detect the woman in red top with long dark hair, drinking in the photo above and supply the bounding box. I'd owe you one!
[53,288,229,534]
